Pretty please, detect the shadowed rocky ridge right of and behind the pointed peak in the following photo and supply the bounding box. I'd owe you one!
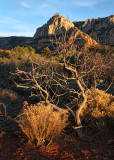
[73,15,114,46]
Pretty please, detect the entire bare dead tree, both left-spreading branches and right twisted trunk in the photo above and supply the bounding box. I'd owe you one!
[13,30,112,139]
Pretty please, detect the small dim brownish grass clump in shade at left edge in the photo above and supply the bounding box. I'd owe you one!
[0,89,18,102]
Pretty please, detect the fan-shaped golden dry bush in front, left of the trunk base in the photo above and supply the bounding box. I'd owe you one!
[17,102,68,146]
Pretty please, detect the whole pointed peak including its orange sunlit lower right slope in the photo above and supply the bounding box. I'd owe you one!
[27,13,97,52]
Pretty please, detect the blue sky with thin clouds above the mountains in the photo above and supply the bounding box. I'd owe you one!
[0,0,114,36]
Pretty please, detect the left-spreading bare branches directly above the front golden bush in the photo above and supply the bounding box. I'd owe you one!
[14,57,66,103]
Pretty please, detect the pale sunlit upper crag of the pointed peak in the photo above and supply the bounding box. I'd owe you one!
[34,13,74,38]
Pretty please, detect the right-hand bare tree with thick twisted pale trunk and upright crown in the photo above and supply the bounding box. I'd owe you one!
[52,31,110,139]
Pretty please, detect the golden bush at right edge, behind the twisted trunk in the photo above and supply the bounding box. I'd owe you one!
[81,89,114,129]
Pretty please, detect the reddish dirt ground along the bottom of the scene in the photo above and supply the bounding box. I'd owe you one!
[0,117,114,160]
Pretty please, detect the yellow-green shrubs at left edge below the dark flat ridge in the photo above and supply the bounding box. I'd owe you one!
[0,46,37,86]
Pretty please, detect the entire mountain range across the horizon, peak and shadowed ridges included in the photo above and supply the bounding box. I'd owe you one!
[0,13,114,53]
